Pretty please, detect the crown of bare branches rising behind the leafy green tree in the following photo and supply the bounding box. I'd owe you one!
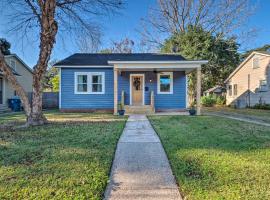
[140,0,254,44]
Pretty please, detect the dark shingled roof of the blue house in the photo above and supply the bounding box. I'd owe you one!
[54,53,185,66]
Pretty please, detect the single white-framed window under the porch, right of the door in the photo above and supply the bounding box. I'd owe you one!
[157,72,173,94]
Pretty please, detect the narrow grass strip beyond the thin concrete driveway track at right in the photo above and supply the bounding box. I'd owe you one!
[203,106,270,123]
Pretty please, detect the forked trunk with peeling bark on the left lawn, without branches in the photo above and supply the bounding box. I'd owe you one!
[0,0,58,126]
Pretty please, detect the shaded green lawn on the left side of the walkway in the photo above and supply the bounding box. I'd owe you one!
[0,111,126,199]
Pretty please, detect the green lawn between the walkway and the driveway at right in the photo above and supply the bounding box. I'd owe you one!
[149,116,270,200]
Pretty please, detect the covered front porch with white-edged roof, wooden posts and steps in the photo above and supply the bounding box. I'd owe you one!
[110,61,206,115]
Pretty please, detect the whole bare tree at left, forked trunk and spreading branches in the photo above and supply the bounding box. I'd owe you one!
[0,0,122,125]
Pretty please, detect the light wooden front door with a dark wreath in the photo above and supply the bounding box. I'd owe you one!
[131,75,144,106]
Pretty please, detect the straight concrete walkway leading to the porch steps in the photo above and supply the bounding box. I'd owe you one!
[105,115,182,200]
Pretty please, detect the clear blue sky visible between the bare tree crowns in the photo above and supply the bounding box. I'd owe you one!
[0,0,270,67]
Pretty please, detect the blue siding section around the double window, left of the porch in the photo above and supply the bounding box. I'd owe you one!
[61,68,113,109]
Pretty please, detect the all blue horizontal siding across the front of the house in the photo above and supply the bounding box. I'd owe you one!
[61,68,186,110]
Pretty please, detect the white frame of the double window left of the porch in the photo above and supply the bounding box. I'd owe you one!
[74,72,105,94]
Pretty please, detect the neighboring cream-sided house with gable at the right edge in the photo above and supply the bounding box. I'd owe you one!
[225,51,270,108]
